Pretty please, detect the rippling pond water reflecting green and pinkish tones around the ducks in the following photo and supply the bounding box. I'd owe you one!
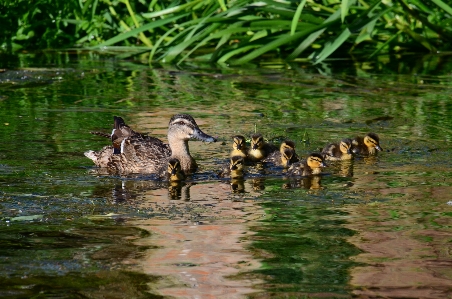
[0,53,452,298]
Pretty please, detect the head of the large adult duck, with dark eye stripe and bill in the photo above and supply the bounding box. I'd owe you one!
[168,114,217,142]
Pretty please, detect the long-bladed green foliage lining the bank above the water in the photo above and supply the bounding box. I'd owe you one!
[0,0,452,64]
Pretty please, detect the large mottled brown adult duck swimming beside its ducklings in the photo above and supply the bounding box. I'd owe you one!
[85,114,217,174]
